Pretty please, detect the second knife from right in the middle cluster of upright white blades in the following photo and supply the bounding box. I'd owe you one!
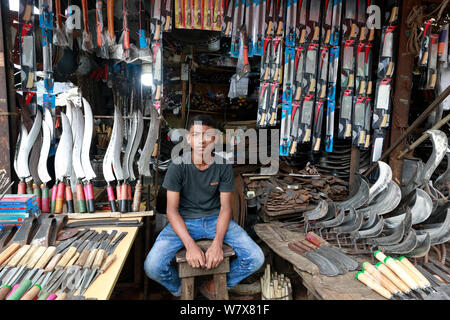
[72,108,87,213]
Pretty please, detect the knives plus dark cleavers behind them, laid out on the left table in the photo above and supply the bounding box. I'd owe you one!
[0,215,127,300]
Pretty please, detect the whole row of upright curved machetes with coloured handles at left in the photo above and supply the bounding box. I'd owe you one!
[14,90,159,213]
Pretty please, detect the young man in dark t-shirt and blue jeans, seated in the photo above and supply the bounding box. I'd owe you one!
[144,115,264,299]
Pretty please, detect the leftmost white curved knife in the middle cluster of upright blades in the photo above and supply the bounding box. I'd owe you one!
[55,112,72,213]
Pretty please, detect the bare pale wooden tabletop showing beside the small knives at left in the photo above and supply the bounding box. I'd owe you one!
[69,217,142,300]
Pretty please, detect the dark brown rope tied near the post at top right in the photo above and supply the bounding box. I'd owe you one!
[406,0,450,57]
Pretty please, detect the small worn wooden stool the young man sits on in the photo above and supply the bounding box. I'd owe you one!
[175,240,234,300]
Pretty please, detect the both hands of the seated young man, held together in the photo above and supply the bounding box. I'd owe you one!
[186,242,223,270]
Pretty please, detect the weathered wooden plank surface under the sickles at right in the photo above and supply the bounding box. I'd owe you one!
[254,222,384,300]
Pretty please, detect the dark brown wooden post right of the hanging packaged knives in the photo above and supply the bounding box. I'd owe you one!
[389,0,420,185]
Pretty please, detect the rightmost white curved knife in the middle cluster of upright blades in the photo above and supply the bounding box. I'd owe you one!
[81,97,96,213]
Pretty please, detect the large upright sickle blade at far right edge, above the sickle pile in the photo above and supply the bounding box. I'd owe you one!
[420,130,448,186]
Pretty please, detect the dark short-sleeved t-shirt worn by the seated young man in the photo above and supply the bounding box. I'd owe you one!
[162,153,234,219]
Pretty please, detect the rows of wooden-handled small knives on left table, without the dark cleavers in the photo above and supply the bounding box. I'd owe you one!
[0,229,127,300]
